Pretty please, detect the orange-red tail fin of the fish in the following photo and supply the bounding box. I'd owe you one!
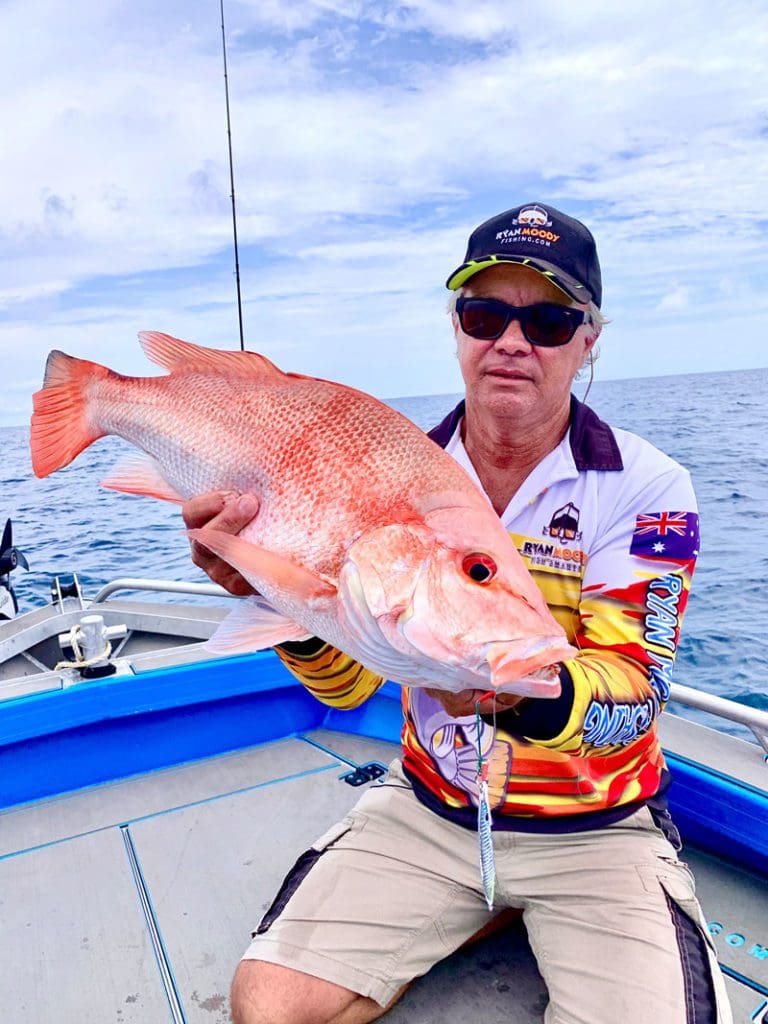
[30,351,112,477]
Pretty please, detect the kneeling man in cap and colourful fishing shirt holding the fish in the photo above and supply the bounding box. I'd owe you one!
[184,204,730,1024]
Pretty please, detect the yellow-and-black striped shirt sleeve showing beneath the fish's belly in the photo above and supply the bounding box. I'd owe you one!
[274,637,384,711]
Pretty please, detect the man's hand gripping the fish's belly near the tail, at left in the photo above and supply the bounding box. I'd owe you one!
[181,490,259,597]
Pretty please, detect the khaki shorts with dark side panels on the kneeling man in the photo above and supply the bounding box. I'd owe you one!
[243,761,731,1024]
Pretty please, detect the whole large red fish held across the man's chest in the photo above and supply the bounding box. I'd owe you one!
[32,333,575,696]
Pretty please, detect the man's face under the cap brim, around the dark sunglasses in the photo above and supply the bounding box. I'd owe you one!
[454,263,598,426]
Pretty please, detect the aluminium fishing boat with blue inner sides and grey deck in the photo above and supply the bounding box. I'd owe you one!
[0,561,768,1024]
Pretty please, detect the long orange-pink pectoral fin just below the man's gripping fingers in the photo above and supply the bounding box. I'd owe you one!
[187,527,337,606]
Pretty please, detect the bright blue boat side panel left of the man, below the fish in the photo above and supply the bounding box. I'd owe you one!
[0,651,402,810]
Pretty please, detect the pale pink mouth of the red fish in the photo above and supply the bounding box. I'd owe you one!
[486,637,578,697]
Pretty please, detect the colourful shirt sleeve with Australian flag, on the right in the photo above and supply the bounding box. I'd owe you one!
[499,464,698,756]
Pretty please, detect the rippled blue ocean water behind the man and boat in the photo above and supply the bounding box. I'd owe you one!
[0,369,768,738]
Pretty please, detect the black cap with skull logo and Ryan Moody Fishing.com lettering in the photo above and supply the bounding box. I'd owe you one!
[445,203,603,306]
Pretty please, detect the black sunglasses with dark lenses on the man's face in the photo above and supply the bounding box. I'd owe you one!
[456,297,592,348]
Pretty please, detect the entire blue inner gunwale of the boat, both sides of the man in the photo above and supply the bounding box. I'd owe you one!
[0,651,768,877]
